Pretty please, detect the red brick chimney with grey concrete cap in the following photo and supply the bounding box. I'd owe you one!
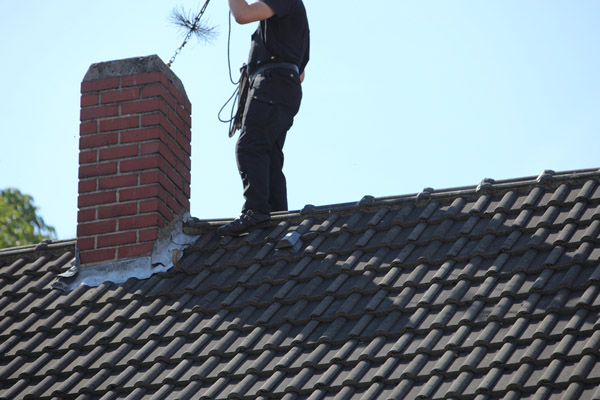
[77,56,191,265]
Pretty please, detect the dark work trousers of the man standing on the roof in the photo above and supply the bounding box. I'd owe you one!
[236,68,302,214]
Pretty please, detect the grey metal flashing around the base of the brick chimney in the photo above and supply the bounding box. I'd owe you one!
[52,216,199,292]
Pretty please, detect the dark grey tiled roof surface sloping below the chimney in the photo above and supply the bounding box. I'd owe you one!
[0,170,600,400]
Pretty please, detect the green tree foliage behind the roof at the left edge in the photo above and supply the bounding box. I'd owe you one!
[0,189,56,248]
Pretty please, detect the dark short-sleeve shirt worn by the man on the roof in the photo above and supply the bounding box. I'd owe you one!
[248,0,310,73]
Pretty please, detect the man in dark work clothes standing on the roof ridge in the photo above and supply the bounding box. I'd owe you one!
[218,0,310,236]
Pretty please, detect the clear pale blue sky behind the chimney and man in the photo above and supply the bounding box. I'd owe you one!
[0,0,600,239]
